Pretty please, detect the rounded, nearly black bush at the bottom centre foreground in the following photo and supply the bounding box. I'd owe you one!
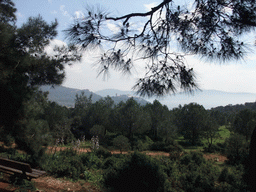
[103,152,166,192]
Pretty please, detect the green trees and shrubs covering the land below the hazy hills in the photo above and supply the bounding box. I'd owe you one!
[1,92,256,192]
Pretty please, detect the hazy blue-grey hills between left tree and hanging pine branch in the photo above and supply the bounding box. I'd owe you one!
[40,86,148,107]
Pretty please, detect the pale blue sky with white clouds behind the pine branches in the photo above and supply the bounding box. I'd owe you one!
[13,0,256,93]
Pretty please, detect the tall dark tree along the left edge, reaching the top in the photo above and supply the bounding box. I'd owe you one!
[0,0,81,150]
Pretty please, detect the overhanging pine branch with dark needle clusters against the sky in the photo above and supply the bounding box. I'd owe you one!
[65,0,256,96]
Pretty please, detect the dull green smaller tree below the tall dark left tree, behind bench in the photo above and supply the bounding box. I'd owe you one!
[12,92,51,163]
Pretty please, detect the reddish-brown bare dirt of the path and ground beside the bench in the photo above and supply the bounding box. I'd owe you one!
[0,147,227,192]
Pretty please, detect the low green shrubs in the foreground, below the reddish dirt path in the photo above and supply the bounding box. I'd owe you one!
[0,143,248,192]
